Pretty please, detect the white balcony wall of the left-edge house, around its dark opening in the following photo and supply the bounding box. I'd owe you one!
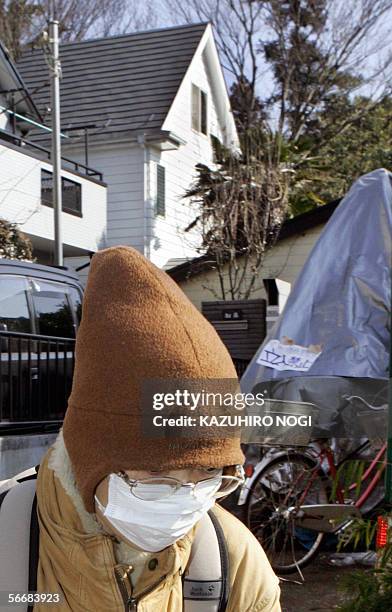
[0,141,106,251]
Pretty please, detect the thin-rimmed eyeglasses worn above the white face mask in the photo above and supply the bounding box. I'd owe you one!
[116,466,245,501]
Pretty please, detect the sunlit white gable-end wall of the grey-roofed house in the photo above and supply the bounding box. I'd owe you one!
[148,49,227,266]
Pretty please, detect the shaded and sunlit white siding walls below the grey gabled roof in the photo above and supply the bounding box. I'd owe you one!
[59,43,234,266]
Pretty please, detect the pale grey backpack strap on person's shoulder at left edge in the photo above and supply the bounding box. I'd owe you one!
[0,466,39,612]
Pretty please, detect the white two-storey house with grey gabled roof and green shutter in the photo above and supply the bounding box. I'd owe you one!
[18,24,238,274]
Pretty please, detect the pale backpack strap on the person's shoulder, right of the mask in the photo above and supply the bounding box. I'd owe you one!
[183,510,229,612]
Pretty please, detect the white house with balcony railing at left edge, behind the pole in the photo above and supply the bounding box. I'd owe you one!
[0,43,106,263]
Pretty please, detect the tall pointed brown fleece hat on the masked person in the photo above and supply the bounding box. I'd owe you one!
[63,246,243,512]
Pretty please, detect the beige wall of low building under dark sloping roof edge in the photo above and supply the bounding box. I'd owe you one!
[179,225,324,310]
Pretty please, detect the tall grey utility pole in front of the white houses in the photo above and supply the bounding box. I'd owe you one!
[49,2,63,266]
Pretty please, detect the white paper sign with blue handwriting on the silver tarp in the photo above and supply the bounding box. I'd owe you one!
[256,340,321,372]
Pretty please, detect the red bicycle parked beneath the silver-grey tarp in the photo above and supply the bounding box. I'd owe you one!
[245,396,386,574]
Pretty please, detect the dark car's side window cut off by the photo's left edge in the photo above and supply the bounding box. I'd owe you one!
[0,274,31,333]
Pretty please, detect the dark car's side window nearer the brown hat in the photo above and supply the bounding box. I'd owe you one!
[31,279,75,338]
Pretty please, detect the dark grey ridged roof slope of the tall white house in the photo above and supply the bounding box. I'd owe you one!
[18,23,208,137]
